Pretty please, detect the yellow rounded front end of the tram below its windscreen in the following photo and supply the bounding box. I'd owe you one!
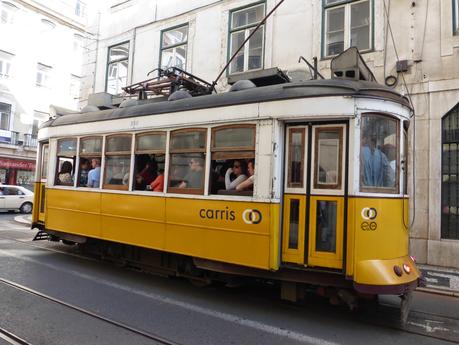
[347,197,419,292]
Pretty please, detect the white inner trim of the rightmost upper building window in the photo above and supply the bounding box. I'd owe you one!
[322,0,373,58]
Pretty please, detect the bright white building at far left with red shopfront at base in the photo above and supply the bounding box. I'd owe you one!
[0,0,92,187]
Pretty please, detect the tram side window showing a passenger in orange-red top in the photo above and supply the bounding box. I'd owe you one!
[133,132,166,192]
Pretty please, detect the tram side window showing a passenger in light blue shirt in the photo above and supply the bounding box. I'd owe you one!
[77,137,102,188]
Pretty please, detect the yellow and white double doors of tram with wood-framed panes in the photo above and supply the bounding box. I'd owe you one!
[282,123,347,269]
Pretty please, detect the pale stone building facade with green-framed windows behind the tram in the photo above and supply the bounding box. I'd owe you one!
[82,0,459,268]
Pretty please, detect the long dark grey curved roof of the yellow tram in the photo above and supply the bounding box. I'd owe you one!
[42,79,410,128]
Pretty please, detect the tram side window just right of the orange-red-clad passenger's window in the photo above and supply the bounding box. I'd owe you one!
[168,128,207,194]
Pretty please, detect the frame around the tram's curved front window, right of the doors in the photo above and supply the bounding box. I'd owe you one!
[357,113,401,195]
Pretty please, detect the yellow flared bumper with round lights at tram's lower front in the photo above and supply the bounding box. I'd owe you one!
[354,256,423,295]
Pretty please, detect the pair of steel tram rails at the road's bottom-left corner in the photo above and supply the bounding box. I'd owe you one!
[0,278,180,345]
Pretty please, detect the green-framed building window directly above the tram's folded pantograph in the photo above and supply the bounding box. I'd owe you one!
[159,24,188,70]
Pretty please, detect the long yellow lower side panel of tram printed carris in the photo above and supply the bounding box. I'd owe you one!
[46,188,279,269]
